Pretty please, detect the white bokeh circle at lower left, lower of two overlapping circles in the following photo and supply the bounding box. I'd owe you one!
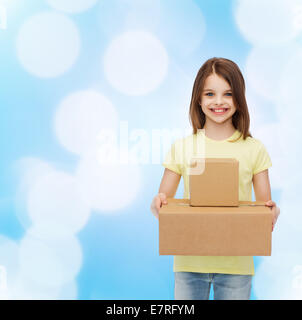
[19,225,82,287]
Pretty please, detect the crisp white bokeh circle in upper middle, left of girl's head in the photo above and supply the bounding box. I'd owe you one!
[103,31,169,96]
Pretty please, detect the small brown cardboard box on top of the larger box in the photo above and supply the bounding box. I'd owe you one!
[189,158,239,207]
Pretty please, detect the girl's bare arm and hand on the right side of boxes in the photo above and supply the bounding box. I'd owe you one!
[253,169,280,230]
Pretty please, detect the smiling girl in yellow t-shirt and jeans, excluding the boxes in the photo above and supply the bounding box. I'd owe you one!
[151,58,280,300]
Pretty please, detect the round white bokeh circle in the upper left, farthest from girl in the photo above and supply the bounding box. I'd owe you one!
[16,11,80,78]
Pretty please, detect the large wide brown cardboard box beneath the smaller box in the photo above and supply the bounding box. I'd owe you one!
[159,198,272,256]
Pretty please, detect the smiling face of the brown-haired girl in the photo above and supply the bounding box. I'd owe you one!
[201,73,236,123]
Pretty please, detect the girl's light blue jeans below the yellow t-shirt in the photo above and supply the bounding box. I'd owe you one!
[174,271,253,300]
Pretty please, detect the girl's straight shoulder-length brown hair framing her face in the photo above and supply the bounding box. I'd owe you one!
[189,58,252,142]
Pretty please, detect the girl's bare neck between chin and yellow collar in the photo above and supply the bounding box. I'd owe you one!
[204,119,236,140]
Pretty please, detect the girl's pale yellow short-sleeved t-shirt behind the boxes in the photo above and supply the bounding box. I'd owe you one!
[162,130,272,275]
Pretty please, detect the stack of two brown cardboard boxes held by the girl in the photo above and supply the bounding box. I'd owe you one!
[159,158,272,256]
